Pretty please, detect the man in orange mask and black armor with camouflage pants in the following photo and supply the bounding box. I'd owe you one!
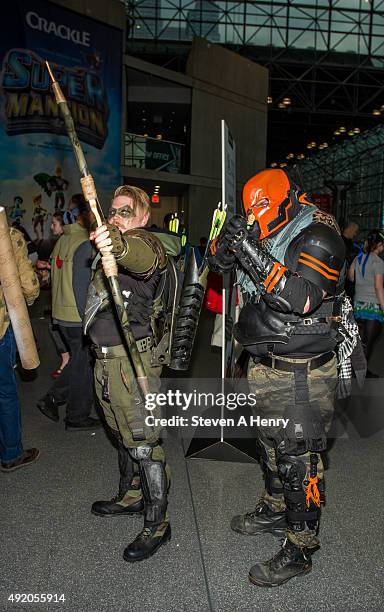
[210,169,345,586]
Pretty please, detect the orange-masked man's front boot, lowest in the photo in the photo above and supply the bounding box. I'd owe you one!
[249,539,312,587]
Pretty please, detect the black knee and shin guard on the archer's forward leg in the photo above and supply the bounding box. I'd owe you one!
[130,446,167,523]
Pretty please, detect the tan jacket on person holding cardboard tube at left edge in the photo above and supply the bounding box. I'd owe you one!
[0,227,40,339]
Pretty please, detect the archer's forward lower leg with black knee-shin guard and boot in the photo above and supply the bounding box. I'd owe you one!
[123,446,171,563]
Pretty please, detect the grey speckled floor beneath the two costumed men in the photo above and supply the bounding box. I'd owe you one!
[0,308,384,612]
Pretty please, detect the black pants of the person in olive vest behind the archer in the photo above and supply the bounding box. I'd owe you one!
[49,325,93,423]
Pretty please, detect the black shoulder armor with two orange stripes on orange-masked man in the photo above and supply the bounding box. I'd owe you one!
[296,222,345,295]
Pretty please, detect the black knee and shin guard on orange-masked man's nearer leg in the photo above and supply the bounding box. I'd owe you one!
[277,455,319,531]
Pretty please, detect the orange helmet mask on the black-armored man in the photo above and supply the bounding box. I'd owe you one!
[243,168,312,240]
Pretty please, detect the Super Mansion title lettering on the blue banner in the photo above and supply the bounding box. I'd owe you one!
[0,49,109,149]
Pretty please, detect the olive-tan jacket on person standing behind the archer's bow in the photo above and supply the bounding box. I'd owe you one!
[51,223,91,325]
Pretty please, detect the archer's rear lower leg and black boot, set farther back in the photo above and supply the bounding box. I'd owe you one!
[91,432,144,517]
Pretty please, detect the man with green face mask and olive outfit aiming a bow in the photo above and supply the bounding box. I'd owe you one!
[85,185,180,562]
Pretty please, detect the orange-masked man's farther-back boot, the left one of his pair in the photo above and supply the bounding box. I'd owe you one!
[231,500,287,536]
